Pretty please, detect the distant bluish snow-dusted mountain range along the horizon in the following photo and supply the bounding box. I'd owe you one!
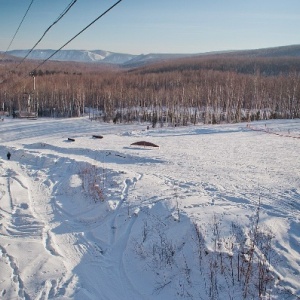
[3,45,300,66]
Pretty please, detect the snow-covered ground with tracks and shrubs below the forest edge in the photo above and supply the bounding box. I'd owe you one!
[0,118,300,300]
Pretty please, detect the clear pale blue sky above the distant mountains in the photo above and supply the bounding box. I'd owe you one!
[0,0,300,54]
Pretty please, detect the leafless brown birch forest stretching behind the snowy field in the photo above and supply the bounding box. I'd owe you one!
[0,54,300,127]
